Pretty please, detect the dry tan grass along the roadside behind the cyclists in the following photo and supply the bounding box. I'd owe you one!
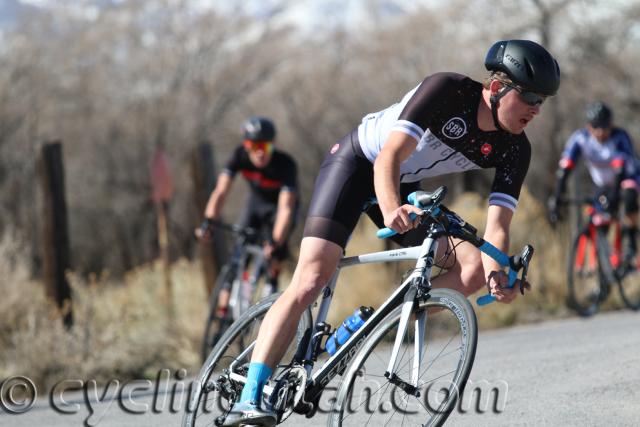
[0,190,632,387]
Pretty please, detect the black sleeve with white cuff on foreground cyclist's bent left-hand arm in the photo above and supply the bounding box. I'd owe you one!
[391,73,459,142]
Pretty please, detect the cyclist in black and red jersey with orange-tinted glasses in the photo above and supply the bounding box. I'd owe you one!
[196,117,298,314]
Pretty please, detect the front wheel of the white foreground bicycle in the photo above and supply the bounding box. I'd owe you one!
[328,289,478,426]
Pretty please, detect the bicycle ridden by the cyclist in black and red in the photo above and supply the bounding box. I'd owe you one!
[201,221,269,361]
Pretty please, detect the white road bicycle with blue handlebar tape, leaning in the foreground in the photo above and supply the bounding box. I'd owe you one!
[182,187,533,427]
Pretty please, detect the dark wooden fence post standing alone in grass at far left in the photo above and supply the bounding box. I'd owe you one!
[39,141,73,328]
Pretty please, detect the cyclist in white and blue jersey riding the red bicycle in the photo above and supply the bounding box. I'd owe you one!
[548,101,640,259]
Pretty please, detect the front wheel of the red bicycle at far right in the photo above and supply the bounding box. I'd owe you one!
[567,232,608,317]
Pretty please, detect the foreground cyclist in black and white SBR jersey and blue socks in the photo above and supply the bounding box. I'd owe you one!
[224,40,560,425]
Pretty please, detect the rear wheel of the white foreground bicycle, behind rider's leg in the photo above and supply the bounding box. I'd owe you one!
[182,293,313,427]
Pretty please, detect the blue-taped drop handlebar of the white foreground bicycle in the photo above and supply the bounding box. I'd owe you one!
[376,186,534,306]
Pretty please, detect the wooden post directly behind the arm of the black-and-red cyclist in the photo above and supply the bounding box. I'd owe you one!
[191,142,228,295]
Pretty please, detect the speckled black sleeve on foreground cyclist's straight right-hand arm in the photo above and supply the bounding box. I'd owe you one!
[489,137,531,211]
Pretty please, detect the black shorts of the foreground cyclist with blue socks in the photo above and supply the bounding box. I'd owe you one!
[303,130,427,249]
